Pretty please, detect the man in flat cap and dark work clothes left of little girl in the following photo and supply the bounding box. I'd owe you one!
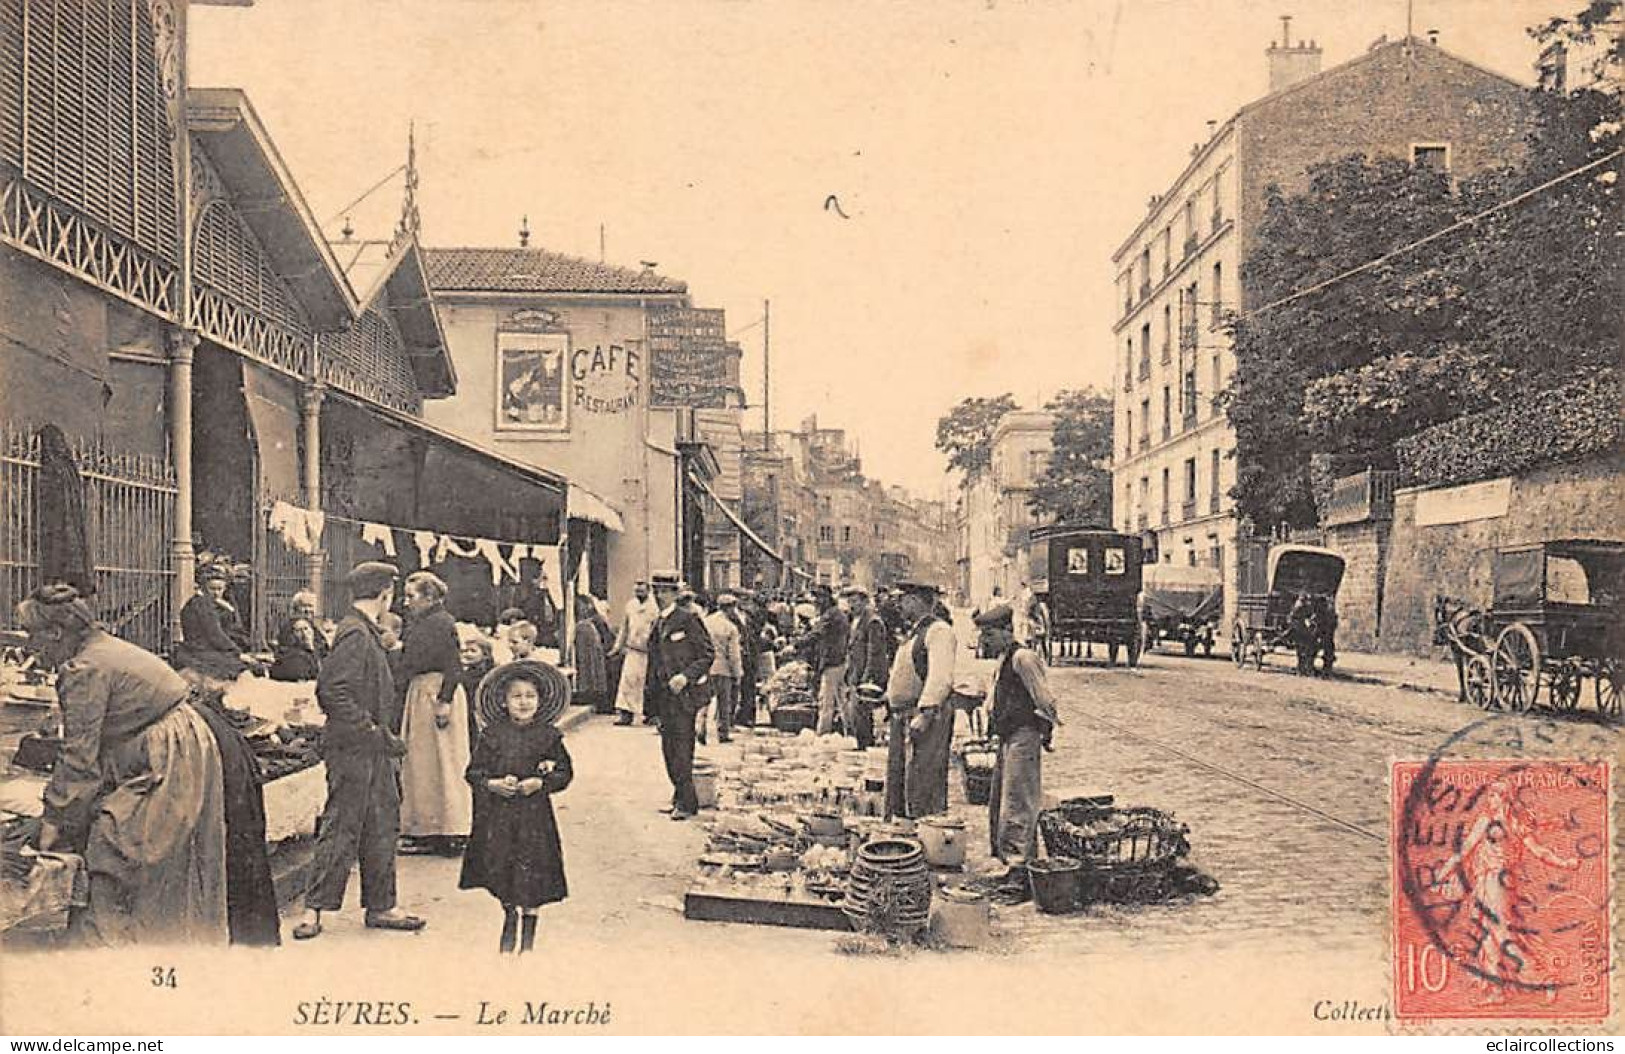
[294,560,424,940]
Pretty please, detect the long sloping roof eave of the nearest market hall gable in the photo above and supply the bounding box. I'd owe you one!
[187,88,359,331]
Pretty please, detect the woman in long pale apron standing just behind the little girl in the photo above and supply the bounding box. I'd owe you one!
[401,572,473,853]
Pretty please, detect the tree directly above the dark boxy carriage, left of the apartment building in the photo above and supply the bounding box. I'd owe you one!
[1027,388,1112,526]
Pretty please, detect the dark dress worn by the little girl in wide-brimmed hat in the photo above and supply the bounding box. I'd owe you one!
[458,718,574,908]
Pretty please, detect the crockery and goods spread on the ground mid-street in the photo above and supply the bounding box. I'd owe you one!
[684,729,949,931]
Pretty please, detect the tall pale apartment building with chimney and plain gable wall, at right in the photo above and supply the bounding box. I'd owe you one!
[1112,24,1534,625]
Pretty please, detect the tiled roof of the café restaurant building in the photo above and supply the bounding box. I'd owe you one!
[423,248,689,292]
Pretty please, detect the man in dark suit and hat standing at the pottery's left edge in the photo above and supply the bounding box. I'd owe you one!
[645,572,717,820]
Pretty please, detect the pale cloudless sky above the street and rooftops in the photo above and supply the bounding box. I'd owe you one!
[189,0,1581,497]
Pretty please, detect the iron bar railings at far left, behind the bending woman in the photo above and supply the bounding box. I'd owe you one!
[0,424,176,653]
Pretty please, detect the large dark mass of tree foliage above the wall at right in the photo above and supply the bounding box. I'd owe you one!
[1225,73,1625,528]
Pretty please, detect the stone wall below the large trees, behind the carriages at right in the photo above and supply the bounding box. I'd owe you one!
[1371,453,1625,654]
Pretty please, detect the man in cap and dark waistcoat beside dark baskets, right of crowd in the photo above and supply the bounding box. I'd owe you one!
[977,604,1061,866]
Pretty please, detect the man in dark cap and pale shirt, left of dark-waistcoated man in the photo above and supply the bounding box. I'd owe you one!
[886,581,957,820]
